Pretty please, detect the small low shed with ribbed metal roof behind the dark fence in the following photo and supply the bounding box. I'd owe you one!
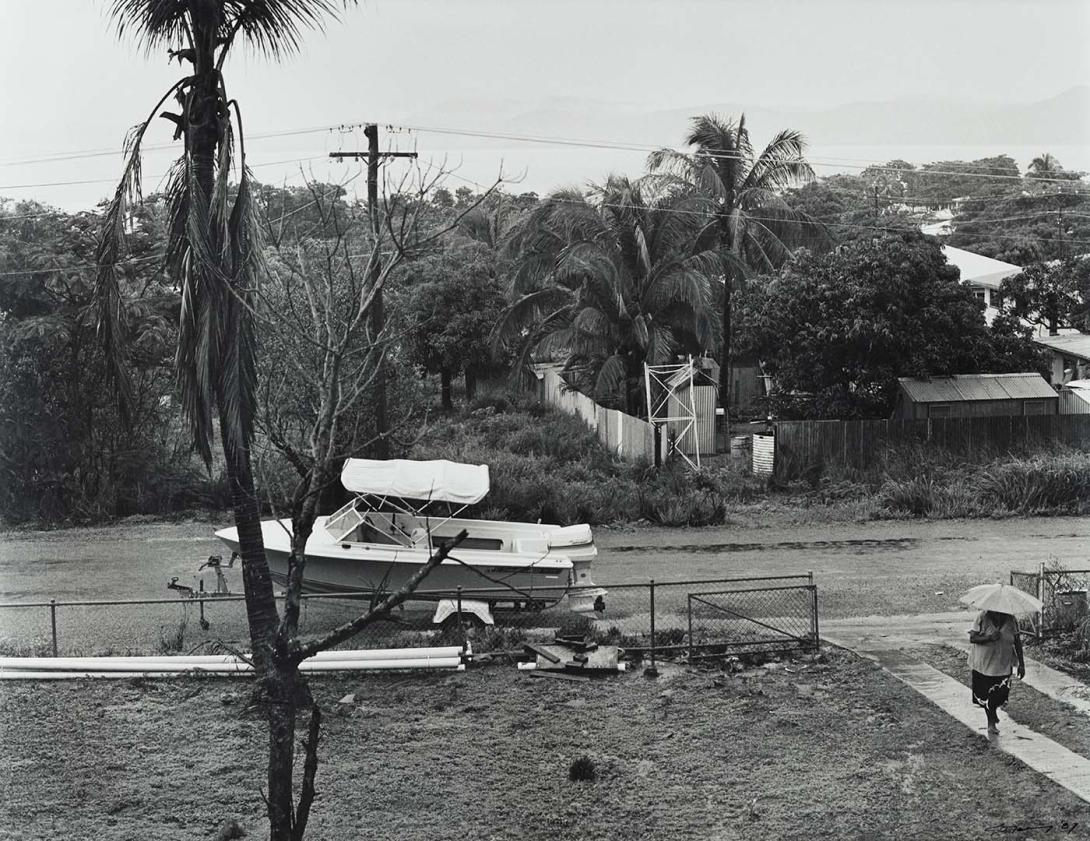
[893,374,1059,419]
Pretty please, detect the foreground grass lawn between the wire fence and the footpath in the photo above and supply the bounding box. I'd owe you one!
[0,650,1090,841]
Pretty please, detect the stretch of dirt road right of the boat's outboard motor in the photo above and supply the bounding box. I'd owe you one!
[594,517,1090,617]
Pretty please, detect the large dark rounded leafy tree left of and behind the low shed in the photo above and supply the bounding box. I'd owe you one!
[740,233,1041,417]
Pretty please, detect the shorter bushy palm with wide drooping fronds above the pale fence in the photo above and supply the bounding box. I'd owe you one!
[496,176,723,414]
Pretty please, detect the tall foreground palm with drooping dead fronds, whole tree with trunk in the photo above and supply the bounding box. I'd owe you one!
[96,0,352,841]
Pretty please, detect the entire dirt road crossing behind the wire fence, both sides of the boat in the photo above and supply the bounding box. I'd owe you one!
[0,517,1090,648]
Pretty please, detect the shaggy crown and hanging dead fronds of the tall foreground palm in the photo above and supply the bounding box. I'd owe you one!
[97,0,343,462]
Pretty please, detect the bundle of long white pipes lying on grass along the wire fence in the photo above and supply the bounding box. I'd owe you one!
[0,657,462,674]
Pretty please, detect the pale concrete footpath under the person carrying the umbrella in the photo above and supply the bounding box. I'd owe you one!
[821,612,1090,803]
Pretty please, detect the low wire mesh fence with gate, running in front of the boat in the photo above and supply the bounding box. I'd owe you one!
[0,572,818,656]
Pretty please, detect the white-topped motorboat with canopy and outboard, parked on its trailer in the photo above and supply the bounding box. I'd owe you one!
[216,459,606,624]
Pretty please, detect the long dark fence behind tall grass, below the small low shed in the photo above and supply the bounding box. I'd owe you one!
[775,414,1090,480]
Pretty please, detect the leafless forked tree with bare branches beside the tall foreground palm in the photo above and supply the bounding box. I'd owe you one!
[247,159,501,840]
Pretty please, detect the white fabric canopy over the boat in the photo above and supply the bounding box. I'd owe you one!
[341,459,488,505]
